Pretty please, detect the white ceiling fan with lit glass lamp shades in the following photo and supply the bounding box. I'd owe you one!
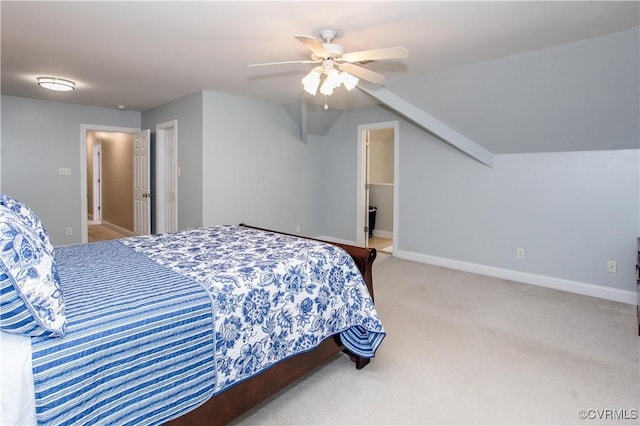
[249,30,409,109]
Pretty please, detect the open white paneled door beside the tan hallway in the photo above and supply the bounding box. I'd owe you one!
[133,129,152,235]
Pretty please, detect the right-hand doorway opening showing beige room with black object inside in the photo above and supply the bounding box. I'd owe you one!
[356,121,399,254]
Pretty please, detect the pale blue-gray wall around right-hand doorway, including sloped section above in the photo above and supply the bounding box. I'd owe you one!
[321,28,640,291]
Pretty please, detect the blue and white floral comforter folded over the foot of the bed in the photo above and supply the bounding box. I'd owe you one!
[121,226,385,393]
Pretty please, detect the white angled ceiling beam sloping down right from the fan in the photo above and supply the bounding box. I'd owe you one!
[357,80,493,167]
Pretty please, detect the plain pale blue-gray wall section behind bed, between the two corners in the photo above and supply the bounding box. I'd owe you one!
[202,91,318,235]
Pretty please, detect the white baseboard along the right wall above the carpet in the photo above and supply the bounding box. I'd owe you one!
[393,245,638,305]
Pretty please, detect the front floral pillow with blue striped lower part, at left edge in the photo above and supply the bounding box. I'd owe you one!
[0,205,67,337]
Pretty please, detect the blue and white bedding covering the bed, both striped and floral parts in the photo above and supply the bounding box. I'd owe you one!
[32,226,384,425]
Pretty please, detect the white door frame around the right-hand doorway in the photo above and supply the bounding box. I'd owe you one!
[356,121,400,251]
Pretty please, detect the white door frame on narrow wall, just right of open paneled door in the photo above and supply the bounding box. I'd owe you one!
[154,120,180,234]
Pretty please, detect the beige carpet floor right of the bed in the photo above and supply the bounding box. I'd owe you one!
[237,254,640,425]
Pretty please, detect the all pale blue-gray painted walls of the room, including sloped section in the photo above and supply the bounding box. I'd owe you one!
[1,25,640,298]
